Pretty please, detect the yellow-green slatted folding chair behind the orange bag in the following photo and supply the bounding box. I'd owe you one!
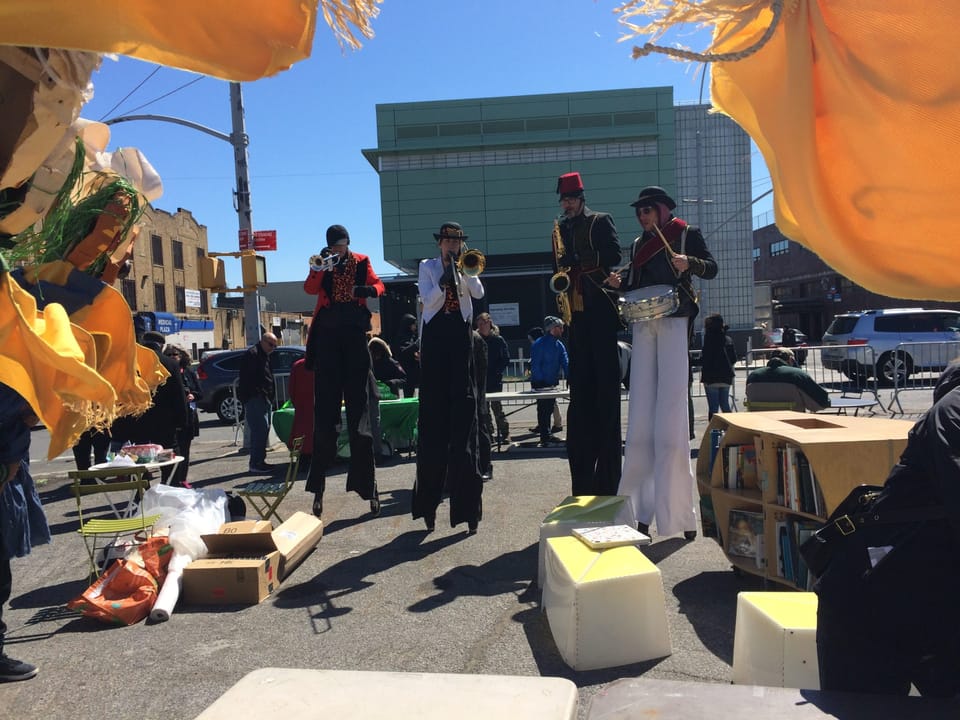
[69,470,160,579]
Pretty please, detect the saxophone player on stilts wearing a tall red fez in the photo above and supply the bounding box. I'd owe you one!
[555,172,623,495]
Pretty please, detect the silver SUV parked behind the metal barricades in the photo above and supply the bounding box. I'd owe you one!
[822,308,960,385]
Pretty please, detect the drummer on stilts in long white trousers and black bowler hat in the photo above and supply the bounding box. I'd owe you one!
[610,186,717,540]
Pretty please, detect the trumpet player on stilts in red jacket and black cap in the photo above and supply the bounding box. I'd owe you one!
[303,225,384,517]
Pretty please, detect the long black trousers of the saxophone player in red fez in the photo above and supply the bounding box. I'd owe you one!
[568,307,623,495]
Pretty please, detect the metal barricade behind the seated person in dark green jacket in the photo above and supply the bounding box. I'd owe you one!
[746,345,885,414]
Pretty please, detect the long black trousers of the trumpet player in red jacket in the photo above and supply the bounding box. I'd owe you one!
[306,326,377,500]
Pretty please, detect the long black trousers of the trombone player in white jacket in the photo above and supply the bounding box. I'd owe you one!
[412,312,483,527]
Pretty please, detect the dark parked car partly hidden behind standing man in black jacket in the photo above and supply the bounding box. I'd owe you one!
[197,345,306,424]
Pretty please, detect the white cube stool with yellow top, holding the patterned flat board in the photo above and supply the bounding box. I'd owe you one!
[543,537,672,670]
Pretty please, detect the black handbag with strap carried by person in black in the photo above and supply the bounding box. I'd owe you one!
[800,485,947,577]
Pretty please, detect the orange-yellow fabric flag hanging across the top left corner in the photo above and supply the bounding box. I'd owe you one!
[0,0,317,81]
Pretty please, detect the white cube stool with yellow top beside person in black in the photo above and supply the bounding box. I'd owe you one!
[733,592,820,690]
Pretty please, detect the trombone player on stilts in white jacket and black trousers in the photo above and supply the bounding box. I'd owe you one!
[412,222,483,534]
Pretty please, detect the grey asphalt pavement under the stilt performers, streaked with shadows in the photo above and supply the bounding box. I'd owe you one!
[0,377,930,720]
